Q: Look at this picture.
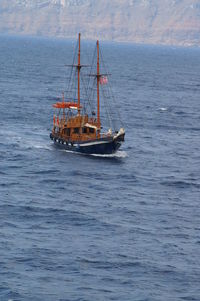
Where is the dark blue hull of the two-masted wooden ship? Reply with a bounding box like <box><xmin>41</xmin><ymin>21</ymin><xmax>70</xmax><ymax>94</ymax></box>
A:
<box><xmin>50</xmin><ymin>133</ymin><xmax>124</xmax><ymax>155</ymax></box>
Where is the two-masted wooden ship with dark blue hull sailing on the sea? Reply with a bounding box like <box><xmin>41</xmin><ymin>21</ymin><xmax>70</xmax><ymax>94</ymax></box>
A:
<box><xmin>50</xmin><ymin>33</ymin><xmax>125</xmax><ymax>155</ymax></box>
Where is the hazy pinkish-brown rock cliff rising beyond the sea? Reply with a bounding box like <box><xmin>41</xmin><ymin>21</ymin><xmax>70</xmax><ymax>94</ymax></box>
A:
<box><xmin>0</xmin><ymin>0</ymin><xmax>200</xmax><ymax>46</ymax></box>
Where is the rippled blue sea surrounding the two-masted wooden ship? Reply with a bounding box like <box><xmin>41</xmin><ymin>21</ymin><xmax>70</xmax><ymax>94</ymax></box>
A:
<box><xmin>0</xmin><ymin>36</ymin><xmax>200</xmax><ymax>301</ymax></box>
